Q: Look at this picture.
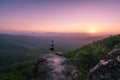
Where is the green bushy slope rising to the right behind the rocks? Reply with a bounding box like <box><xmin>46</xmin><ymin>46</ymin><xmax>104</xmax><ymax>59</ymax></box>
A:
<box><xmin>65</xmin><ymin>35</ymin><xmax>120</xmax><ymax>80</ymax></box>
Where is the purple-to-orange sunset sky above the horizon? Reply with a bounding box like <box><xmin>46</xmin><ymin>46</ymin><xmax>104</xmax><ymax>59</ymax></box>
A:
<box><xmin>0</xmin><ymin>0</ymin><xmax>120</xmax><ymax>34</ymax></box>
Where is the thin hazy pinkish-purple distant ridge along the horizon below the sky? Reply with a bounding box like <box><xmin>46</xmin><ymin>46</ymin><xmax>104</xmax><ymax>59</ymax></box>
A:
<box><xmin>0</xmin><ymin>31</ymin><xmax>90</xmax><ymax>36</ymax></box>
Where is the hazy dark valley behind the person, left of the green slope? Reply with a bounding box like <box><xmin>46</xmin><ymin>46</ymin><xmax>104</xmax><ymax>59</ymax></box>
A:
<box><xmin>0</xmin><ymin>34</ymin><xmax>103</xmax><ymax>80</ymax></box>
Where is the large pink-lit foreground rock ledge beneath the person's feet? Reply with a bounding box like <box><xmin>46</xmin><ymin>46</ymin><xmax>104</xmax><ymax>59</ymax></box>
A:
<box><xmin>32</xmin><ymin>54</ymin><xmax>77</xmax><ymax>80</ymax></box>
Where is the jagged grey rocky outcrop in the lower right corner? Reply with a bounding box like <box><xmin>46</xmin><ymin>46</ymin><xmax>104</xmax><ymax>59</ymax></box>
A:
<box><xmin>89</xmin><ymin>49</ymin><xmax>120</xmax><ymax>80</ymax></box>
